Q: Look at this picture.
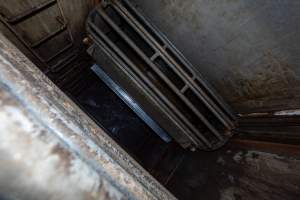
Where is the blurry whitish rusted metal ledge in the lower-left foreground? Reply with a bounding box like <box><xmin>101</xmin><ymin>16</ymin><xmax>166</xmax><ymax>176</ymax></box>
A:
<box><xmin>0</xmin><ymin>34</ymin><xmax>174</xmax><ymax>199</ymax></box>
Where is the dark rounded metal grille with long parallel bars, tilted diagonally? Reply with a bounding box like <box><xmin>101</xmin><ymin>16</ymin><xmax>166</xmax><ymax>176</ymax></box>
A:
<box><xmin>87</xmin><ymin>1</ymin><xmax>234</xmax><ymax>150</ymax></box>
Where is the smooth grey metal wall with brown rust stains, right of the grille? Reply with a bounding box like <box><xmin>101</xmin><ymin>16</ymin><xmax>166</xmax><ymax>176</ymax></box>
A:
<box><xmin>131</xmin><ymin>0</ymin><xmax>300</xmax><ymax>113</ymax></box>
